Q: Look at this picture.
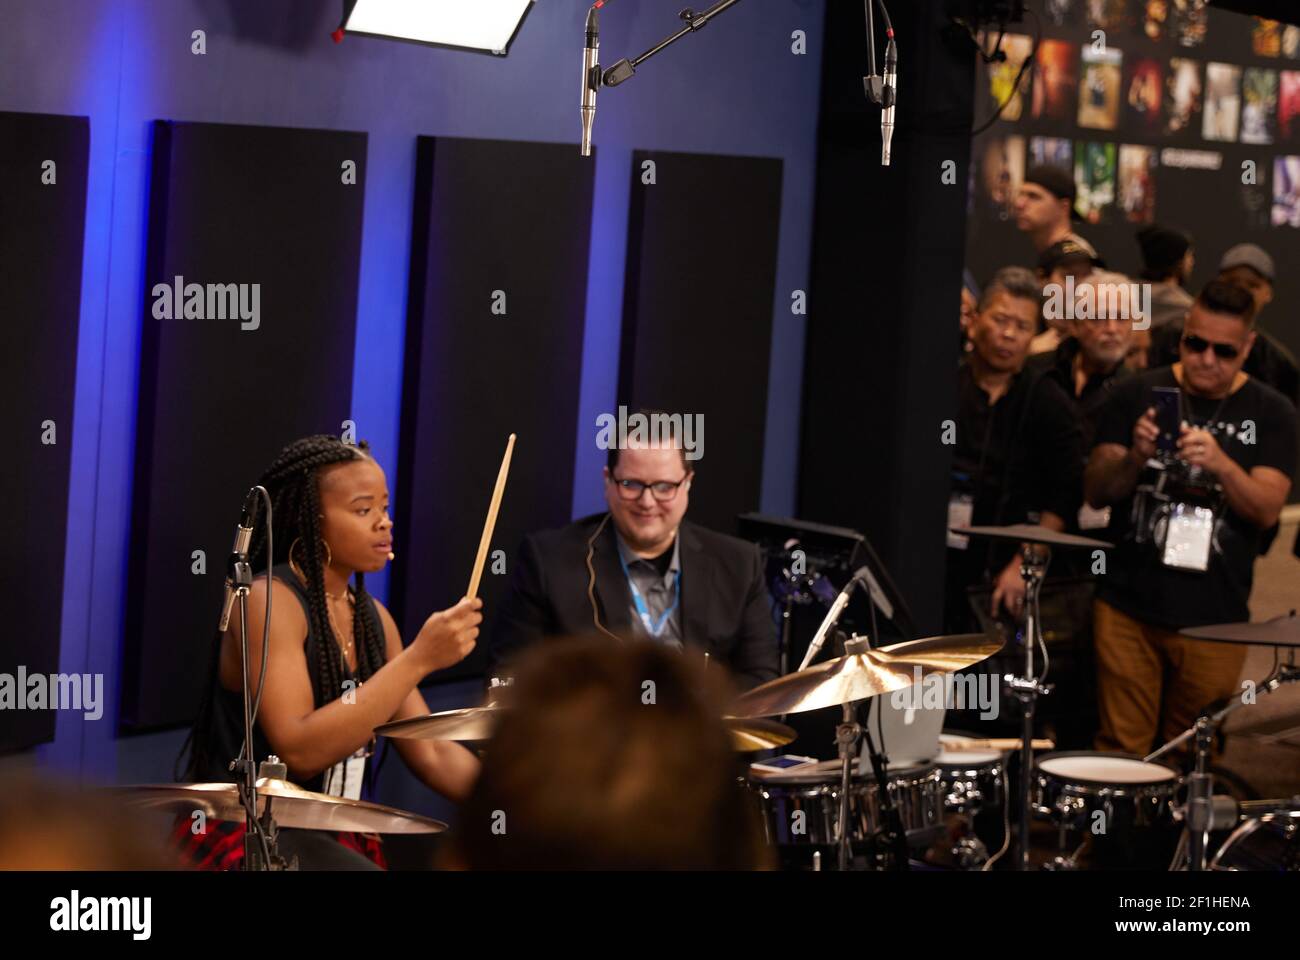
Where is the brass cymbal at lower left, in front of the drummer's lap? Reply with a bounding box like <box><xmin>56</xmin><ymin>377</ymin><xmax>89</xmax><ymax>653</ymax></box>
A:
<box><xmin>109</xmin><ymin>777</ymin><xmax>447</xmax><ymax>834</ymax></box>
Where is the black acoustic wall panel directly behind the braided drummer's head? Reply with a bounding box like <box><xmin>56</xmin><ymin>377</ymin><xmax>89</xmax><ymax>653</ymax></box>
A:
<box><xmin>121</xmin><ymin>121</ymin><xmax>367</xmax><ymax>730</ymax></box>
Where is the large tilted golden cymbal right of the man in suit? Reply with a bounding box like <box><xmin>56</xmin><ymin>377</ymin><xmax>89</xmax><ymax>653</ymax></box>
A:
<box><xmin>731</xmin><ymin>633</ymin><xmax>1002</xmax><ymax>717</ymax></box>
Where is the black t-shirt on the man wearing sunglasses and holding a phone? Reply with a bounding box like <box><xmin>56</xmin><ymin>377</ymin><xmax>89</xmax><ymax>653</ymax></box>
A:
<box><xmin>1097</xmin><ymin>367</ymin><xmax>1296</xmax><ymax>630</ymax></box>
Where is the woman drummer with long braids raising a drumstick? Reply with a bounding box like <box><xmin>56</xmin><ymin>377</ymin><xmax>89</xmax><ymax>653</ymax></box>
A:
<box><xmin>176</xmin><ymin>434</ymin><xmax>482</xmax><ymax>869</ymax></box>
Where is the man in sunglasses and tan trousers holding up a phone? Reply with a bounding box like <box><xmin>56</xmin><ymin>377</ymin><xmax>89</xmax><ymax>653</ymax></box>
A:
<box><xmin>1084</xmin><ymin>280</ymin><xmax>1296</xmax><ymax>756</ymax></box>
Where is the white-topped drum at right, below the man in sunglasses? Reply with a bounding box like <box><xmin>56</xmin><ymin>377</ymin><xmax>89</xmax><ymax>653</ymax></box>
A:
<box><xmin>1034</xmin><ymin>751</ymin><xmax>1180</xmax><ymax>833</ymax></box>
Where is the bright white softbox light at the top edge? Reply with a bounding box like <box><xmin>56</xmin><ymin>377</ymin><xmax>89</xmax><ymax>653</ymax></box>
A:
<box><xmin>343</xmin><ymin>0</ymin><xmax>533</xmax><ymax>56</ymax></box>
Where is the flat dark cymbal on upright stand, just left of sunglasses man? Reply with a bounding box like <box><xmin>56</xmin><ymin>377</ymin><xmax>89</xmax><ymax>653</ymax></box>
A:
<box><xmin>950</xmin><ymin>523</ymin><xmax>1112</xmax><ymax>870</ymax></box>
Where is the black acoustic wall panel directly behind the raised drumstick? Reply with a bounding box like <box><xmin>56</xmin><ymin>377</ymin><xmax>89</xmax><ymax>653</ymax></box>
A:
<box><xmin>393</xmin><ymin>138</ymin><xmax>595</xmax><ymax>680</ymax></box>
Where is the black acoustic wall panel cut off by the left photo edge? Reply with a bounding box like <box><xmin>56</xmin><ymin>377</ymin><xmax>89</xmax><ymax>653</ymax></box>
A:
<box><xmin>0</xmin><ymin>113</ymin><xmax>90</xmax><ymax>753</ymax></box>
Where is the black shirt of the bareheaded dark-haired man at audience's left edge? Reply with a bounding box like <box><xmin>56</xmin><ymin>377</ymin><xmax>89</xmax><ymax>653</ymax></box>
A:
<box><xmin>948</xmin><ymin>363</ymin><xmax>1083</xmax><ymax>591</ymax></box>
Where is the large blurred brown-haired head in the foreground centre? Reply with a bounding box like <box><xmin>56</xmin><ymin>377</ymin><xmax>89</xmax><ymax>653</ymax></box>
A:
<box><xmin>449</xmin><ymin>637</ymin><xmax>770</xmax><ymax>870</ymax></box>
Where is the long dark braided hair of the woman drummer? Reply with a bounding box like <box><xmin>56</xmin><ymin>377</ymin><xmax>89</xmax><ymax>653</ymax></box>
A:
<box><xmin>177</xmin><ymin>433</ymin><xmax>387</xmax><ymax>779</ymax></box>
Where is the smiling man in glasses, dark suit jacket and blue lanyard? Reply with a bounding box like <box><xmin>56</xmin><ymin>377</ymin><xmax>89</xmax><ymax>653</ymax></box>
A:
<box><xmin>489</xmin><ymin>429</ymin><xmax>777</xmax><ymax>689</ymax></box>
